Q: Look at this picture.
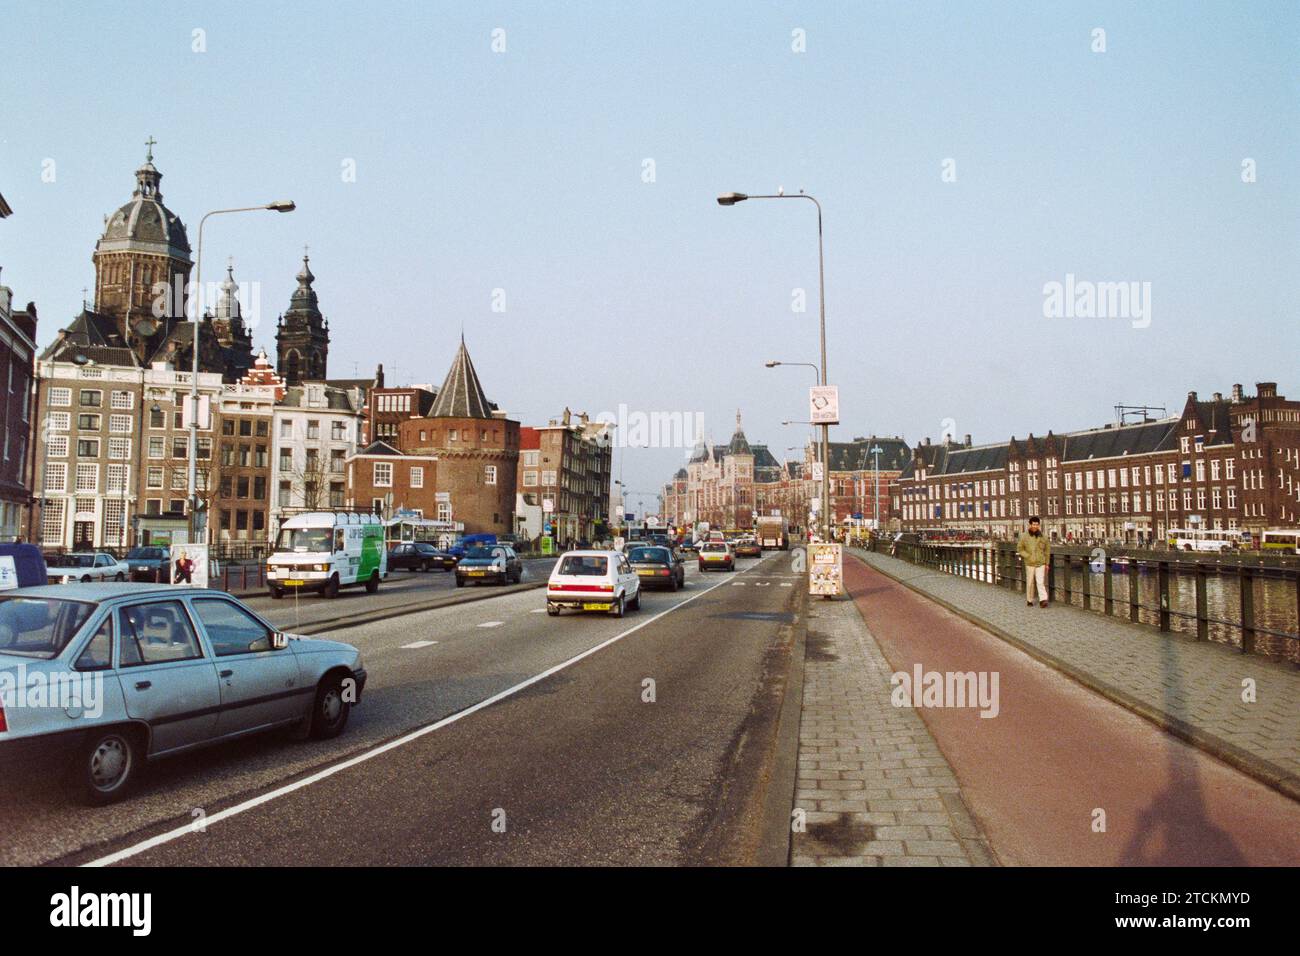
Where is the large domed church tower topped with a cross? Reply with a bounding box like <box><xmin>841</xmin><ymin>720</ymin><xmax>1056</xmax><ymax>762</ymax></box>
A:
<box><xmin>91</xmin><ymin>137</ymin><xmax>192</xmax><ymax>363</ymax></box>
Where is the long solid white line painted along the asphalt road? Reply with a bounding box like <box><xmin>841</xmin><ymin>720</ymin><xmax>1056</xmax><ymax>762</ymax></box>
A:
<box><xmin>82</xmin><ymin>556</ymin><xmax>750</xmax><ymax>868</ymax></box>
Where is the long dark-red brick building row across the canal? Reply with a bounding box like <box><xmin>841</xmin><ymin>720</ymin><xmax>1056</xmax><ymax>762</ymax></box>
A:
<box><xmin>892</xmin><ymin>382</ymin><xmax>1300</xmax><ymax>542</ymax></box>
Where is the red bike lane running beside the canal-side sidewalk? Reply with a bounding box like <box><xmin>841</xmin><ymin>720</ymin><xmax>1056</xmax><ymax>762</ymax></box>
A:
<box><xmin>844</xmin><ymin>558</ymin><xmax>1300</xmax><ymax>866</ymax></box>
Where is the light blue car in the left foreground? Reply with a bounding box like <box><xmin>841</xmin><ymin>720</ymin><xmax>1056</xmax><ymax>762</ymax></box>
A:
<box><xmin>0</xmin><ymin>584</ymin><xmax>365</xmax><ymax>804</ymax></box>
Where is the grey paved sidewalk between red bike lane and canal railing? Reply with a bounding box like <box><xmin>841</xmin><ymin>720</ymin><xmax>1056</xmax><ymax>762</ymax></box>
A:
<box><xmin>852</xmin><ymin>550</ymin><xmax>1300</xmax><ymax>800</ymax></box>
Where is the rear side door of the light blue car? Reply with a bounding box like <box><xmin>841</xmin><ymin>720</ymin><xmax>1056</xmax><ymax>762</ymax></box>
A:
<box><xmin>117</xmin><ymin>600</ymin><xmax>221</xmax><ymax>754</ymax></box>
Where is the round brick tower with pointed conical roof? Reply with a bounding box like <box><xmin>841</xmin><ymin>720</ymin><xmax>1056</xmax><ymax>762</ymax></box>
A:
<box><xmin>398</xmin><ymin>338</ymin><xmax>519</xmax><ymax>535</ymax></box>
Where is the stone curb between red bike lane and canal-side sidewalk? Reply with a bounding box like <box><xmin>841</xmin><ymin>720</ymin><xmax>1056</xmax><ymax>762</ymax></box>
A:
<box><xmin>852</xmin><ymin>554</ymin><xmax>1300</xmax><ymax>803</ymax></box>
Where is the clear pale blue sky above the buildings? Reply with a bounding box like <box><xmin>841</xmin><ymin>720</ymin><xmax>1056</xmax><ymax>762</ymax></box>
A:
<box><xmin>0</xmin><ymin>0</ymin><xmax>1300</xmax><ymax>522</ymax></box>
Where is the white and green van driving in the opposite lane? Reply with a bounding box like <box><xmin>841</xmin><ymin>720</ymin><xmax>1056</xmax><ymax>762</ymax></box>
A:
<box><xmin>267</xmin><ymin>511</ymin><xmax>389</xmax><ymax>600</ymax></box>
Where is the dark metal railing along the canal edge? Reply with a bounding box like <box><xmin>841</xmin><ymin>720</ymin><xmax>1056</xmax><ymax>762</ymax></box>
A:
<box><xmin>870</xmin><ymin>538</ymin><xmax>1300</xmax><ymax>662</ymax></box>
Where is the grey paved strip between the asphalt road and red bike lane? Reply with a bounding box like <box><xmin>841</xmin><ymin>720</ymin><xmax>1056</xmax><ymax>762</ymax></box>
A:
<box><xmin>790</xmin><ymin>590</ymin><xmax>996</xmax><ymax>866</ymax></box>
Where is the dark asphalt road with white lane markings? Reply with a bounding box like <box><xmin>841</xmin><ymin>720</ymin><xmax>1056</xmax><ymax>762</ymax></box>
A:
<box><xmin>0</xmin><ymin>555</ymin><xmax>800</xmax><ymax>865</ymax></box>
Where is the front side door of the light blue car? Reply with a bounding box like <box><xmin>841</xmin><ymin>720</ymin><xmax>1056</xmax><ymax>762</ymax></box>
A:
<box><xmin>190</xmin><ymin>597</ymin><xmax>306</xmax><ymax>737</ymax></box>
